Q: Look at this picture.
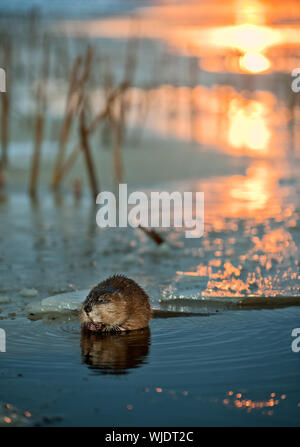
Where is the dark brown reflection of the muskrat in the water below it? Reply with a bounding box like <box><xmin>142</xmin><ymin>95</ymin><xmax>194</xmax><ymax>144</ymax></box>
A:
<box><xmin>81</xmin><ymin>328</ymin><xmax>150</xmax><ymax>374</ymax></box>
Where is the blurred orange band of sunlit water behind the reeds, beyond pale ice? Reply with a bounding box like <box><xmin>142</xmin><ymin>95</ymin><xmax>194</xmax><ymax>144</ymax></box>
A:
<box><xmin>106</xmin><ymin>85</ymin><xmax>289</xmax><ymax>157</ymax></box>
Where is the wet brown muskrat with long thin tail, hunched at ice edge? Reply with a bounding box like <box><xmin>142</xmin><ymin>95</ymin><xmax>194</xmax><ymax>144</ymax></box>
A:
<box><xmin>80</xmin><ymin>275</ymin><xmax>210</xmax><ymax>332</ymax></box>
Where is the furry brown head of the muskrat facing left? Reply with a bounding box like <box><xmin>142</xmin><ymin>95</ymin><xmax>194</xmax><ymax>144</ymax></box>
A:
<box><xmin>80</xmin><ymin>286</ymin><xmax>128</xmax><ymax>332</ymax></box>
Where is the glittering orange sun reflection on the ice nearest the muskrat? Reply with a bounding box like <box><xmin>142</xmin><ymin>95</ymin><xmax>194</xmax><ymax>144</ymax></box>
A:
<box><xmin>165</xmin><ymin>160</ymin><xmax>300</xmax><ymax>299</ymax></box>
